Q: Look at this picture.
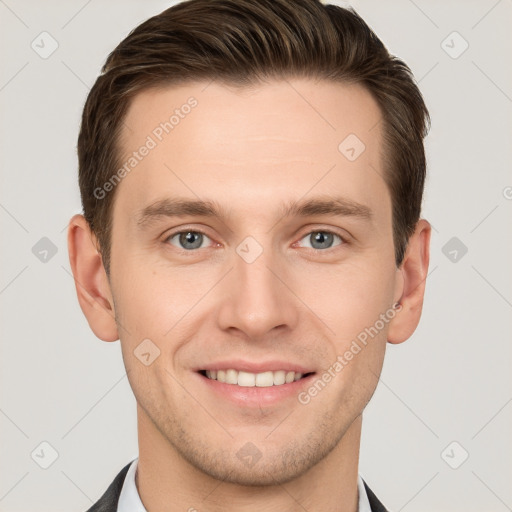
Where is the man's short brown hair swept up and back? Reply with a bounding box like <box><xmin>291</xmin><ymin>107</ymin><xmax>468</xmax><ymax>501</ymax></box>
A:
<box><xmin>78</xmin><ymin>0</ymin><xmax>430</xmax><ymax>274</ymax></box>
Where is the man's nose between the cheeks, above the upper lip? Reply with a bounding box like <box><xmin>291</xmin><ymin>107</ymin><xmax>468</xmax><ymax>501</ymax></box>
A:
<box><xmin>218</xmin><ymin>250</ymin><xmax>299</xmax><ymax>340</ymax></box>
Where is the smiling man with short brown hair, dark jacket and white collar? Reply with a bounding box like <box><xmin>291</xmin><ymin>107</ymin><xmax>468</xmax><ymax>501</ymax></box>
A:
<box><xmin>68</xmin><ymin>0</ymin><xmax>430</xmax><ymax>512</ymax></box>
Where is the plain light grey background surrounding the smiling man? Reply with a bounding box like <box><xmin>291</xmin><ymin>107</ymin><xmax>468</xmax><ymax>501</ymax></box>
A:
<box><xmin>0</xmin><ymin>0</ymin><xmax>512</xmax><ymax>512</ymax></box>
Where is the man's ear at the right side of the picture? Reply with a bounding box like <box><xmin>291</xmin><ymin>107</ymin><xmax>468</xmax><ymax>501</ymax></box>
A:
<box><xmin>388</xmin><ymin>219</ymin><xmax>432</xmax><ymax>343</ymax></box>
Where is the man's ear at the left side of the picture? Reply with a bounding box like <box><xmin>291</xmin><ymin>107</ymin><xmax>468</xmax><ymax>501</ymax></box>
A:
<box><xmin>68</xmin><ymin>215</ymin><xmax>119</xmax><ymax>341</ymax></box>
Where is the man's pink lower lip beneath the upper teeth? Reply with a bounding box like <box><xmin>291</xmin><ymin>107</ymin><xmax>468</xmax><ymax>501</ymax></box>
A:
<box><xmin>197</xmin><ymin>373</ymin><xmax>315</xmax><ymax>407</ymax></box>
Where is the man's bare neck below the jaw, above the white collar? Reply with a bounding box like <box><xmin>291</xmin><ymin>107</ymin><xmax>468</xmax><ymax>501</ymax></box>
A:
<box><xmin>136</xmin><ymin>406</ymin><xmax>362</xmax><ymax>512</ymax></box>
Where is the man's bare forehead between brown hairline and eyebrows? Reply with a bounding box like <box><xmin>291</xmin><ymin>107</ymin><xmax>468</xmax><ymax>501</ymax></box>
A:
<box><xmin>116</xmin><ymin>79</ymin><xmax>386</xmax><ymax>222</ymax></box>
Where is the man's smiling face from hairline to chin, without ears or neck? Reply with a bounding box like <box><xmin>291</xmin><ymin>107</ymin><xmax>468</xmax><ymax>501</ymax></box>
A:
<box><xmin>110</xmin><ymin>79</ymin><xmax>401</xmax><ymax>485</ymax></box>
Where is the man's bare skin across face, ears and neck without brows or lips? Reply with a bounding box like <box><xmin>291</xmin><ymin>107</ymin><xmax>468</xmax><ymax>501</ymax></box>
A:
<box><xmin>68</xmin><ymin>79</ymin><xmax>430</xmax><ymax>512</ymax></box>
